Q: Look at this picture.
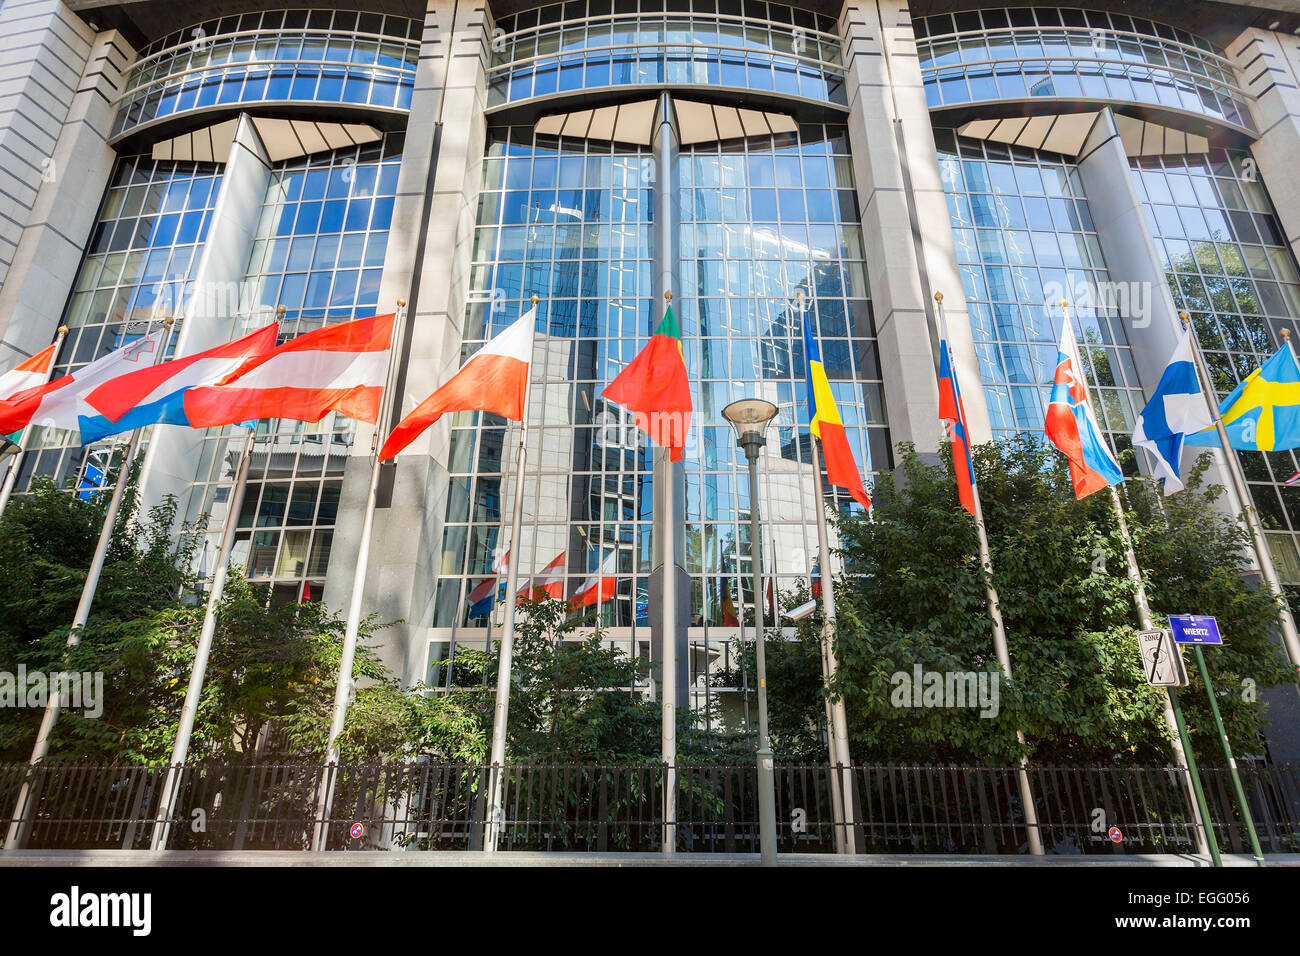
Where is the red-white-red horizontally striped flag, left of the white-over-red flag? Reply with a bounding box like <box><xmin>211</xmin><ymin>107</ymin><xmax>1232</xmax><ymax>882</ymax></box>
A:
<box><xmin>185</xmin><ymin>315</ymin><xmax>394</xmax><ymax>428</ymax></box>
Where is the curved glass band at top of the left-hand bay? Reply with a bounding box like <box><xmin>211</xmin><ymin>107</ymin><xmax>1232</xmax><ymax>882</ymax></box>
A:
<box><xmin>112</xmin><ymin>10</ymin><xmax>423</xmax><ymax>137</ymax></box>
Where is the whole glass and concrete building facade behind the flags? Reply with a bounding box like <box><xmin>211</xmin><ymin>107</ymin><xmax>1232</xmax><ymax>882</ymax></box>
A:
<box><xmin>0</xmin><ymin>0</ymin><xmax>1300</xmax><ymax>749</ymax></box>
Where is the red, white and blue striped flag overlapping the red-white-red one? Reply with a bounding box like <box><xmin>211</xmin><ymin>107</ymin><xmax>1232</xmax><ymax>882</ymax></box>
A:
<box><xmin>79</xmin><ymin>323</ymin><xmax>280</xmax><ymax>445</ymax></box>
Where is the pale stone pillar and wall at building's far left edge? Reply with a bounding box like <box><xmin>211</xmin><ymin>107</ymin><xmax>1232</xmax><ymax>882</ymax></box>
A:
<box><xmin>0</xmin><ymin>18</ymin><xmax>135</xmax><ymax>368</ymax></box>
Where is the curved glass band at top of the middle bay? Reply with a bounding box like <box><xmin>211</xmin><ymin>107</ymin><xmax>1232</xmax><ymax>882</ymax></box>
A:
<box><xmin>488</xmin><ymin>0</ymin><xmax>846</xmax><ymax>107</ymax></box>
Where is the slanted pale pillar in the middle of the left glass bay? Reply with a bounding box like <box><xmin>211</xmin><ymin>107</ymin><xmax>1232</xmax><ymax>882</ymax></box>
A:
<box><xmin>140</xmin><ymin>113</ymin><xmax>274</xmax><ymax>527</ymax></box>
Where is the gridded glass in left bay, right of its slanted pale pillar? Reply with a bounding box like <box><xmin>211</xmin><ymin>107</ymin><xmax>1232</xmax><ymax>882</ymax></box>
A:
<box><xmin>187</xmin><ymin>134</ymin><xmax>403</xmax><ymax>600</ymax></box>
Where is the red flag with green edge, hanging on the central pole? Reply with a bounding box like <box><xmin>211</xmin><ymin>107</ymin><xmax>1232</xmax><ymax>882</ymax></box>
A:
<box><xmin>601</xmin><ymin>306</ymin><xmax>692</xmax><ymax>462</ymax></box>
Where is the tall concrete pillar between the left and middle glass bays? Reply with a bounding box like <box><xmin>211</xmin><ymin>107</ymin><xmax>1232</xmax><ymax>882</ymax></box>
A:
<box><xmin>322</xmin><ymin>0</ymin><xmax>488</xmax><ymax>683</ymax></box>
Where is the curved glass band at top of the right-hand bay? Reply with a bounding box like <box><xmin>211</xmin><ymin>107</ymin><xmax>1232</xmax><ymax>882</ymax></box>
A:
<box><xmin>913</xmin><ymin>7</ymin><xmax>1255</xmax><ymax>130</ymax></box>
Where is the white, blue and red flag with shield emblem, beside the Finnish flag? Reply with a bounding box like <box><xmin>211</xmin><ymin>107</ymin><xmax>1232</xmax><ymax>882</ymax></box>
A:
<box><xmin>1044</xmin><ymin>320</ymin><xmax>1125</xmax><ymax>498</ymax></box>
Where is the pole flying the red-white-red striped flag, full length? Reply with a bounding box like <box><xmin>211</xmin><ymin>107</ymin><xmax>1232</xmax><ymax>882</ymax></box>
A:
<box><xmin>312</xmin><ymin>299</ymin><xmax>406</xmax><ymax>851</ymax></box>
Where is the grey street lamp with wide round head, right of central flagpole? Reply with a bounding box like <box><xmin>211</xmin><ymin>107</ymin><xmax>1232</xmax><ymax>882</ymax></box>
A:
<box><xmin>723</xmin><ymin>398</ymin><xmax>776</xmax><ymax>866</ymax></box>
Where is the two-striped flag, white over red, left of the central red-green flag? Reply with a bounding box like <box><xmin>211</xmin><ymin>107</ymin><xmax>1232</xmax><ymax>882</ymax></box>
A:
<box><xmin>380</xmin><ymin>308</ymin><xmax>537</xmax><ymax>462</ymax></box>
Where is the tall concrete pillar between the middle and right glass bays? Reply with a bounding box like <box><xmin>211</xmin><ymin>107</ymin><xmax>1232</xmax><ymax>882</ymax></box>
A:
<box><xmin>840</xmin><ymin>0</ymin><xmax>992</xmax><ymax>453</ymax></box>
